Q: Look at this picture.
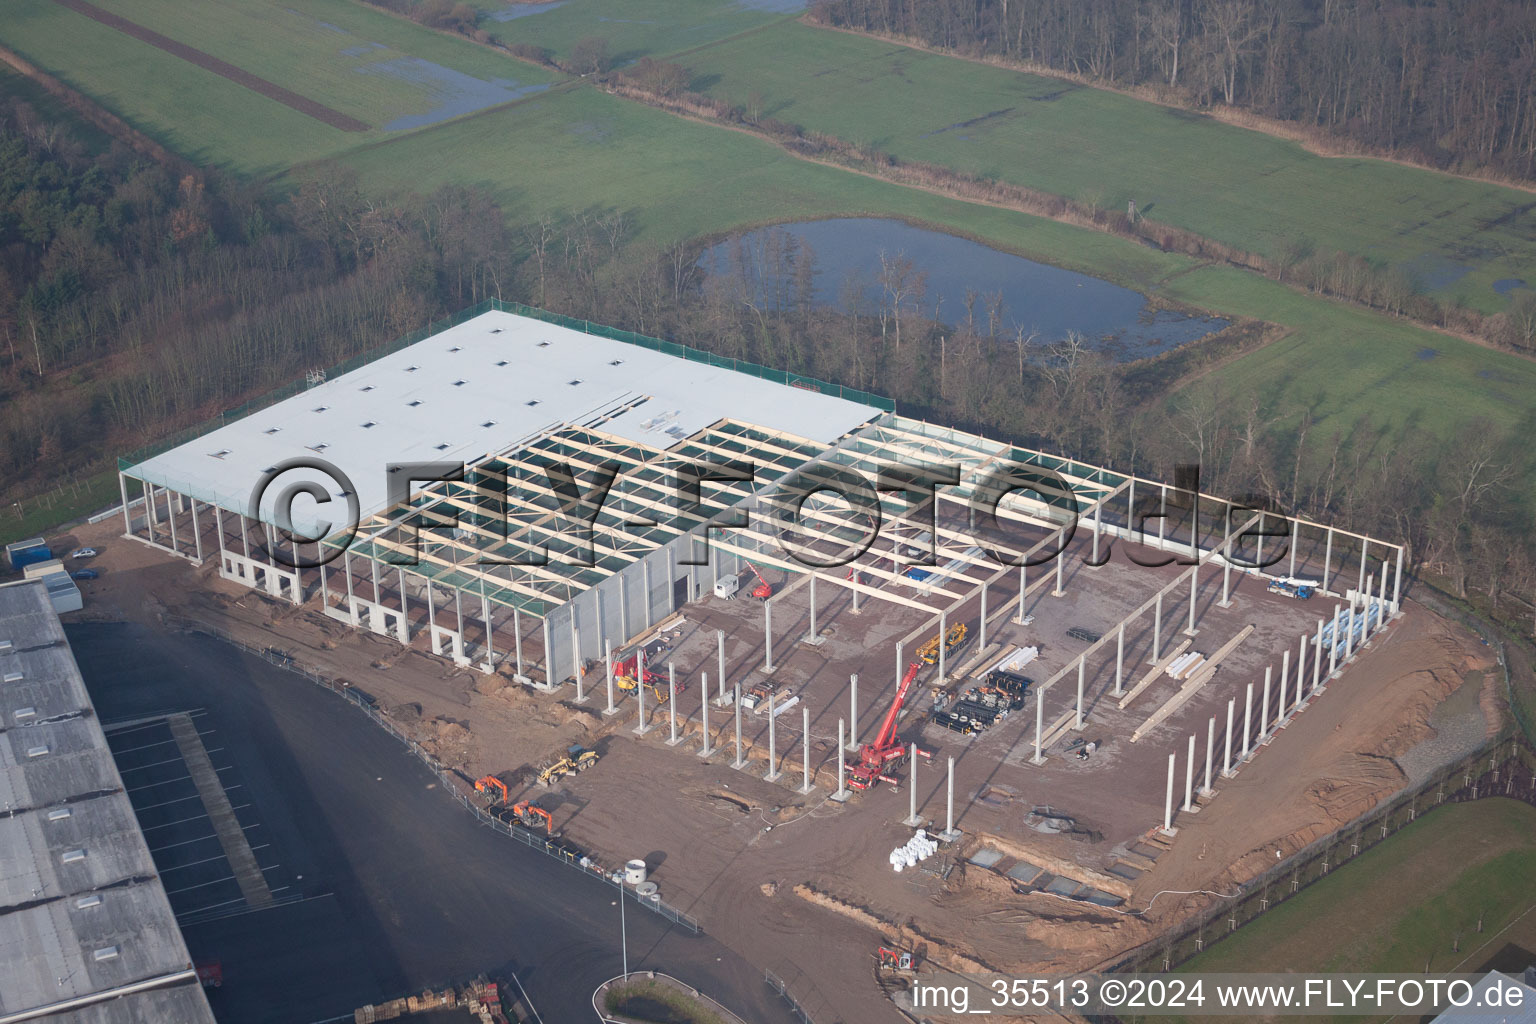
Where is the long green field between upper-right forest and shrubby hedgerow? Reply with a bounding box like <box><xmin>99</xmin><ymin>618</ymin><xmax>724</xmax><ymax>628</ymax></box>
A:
<box><xmin>684</xmin><ymin>21</ymin><xmax>1536</xmax><ymax>310</ymax></box>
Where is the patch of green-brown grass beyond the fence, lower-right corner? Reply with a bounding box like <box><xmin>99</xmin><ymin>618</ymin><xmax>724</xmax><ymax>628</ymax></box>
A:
<box><xmin>1180</xmin><ymin>798</ymin><xmax>1536</xmax><ymax>973</ymax></box>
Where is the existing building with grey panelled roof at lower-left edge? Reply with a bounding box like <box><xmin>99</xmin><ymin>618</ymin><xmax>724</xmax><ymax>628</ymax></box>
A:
<box><xmin>0</xmin><ymin>580</ymin><xmax>214</xmax><ymax>1024</ymax></box>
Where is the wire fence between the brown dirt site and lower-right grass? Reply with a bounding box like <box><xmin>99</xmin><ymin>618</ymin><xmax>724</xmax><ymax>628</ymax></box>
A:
<box><xmin>1106</xmin><ymin>731</ymin><xmax>1536</xmax><ymax>973</ymax></box>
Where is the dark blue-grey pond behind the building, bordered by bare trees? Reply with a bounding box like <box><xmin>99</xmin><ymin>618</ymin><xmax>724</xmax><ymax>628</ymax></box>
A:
<box><xmin>699</xmin><ymin>216</ymin><xmax>1227</xmax><ymax>362</ymax></box>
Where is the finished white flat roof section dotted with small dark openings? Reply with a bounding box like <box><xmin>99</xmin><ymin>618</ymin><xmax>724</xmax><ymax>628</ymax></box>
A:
<box><xmin>127</xmin><ymin>312</ymin><xmax>883</xmax><ymax>536</ymax></box>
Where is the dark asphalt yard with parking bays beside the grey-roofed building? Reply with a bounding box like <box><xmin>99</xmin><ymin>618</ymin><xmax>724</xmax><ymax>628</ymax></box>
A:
<box><xmin>69</xmin><ymin>623</ymin><xmax>794</xmax><ymax>1024</ymax></box>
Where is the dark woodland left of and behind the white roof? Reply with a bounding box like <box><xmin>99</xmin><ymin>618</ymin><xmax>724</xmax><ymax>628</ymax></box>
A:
<box><xmin>0</xmin><ymin>98</ymin><xmax>510</xmax><ymax>499</ymax></box>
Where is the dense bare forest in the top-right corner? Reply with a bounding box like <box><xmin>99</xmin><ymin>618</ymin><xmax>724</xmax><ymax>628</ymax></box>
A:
<box><xmin>811</xmin><ymin>0</ymin><xmax>1536</xmax><ymax>178</ymax></box>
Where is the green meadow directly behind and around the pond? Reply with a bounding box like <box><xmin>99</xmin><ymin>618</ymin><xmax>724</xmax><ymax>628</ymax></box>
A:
<box><xmin>344</xmin><ymin>88</ymin><xmax>1536</xmax><ymax>466</ymax></box>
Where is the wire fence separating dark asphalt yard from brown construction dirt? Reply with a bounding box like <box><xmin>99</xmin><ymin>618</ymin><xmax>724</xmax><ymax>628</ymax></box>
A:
<box><xmin>186</xmin><ymin>623</ymin><xmax>703</xmax><ymax>935</ymax></box>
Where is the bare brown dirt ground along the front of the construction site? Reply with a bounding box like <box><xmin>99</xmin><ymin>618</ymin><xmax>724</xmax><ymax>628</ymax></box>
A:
<box><xmin>54</xmin><ymin>520</ymin><xmax>1498</xmax><ymax>1024</ymax></box>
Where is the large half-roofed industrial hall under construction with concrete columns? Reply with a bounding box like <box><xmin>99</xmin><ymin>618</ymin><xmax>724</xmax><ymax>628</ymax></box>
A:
<box><xmin>120</xmin><ymin>304</ymin><xmax>1402</xmax><ymax>827</ymax></box>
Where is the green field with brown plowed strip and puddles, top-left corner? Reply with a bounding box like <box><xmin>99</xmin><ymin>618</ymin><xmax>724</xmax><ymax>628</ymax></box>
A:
<box><xmin>0</xmin><ymin>0</ymin><xmax>554</xmax><ymax>173</ymax></box>
